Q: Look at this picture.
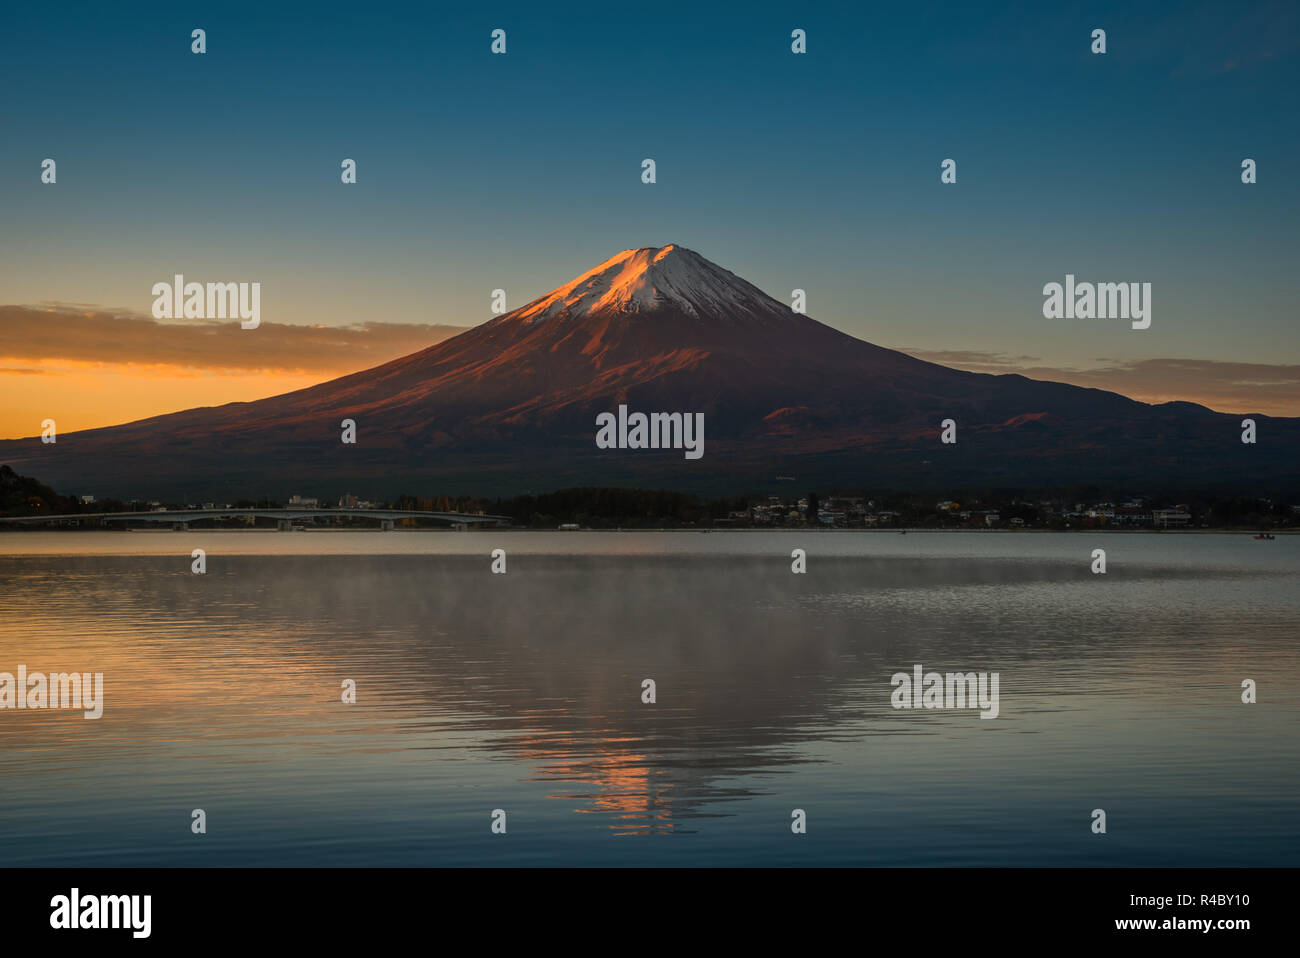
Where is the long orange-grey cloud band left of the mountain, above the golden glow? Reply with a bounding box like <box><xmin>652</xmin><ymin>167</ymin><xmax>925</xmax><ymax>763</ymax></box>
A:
<box><xmin>0</xmin><ymin>303</ymin><xmax>464</xmax><ymax>374</ymax></box>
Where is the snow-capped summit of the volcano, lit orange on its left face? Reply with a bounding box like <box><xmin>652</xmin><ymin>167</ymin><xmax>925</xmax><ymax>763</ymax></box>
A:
<box><xmin>515</xmin><ymin>243</ymin><xmax>788</xmax><ymax>322</ymax></box>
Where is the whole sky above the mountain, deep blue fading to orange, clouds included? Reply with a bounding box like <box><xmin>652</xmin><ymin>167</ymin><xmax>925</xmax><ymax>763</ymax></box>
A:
<box><xmin>0</xmin><ymin>3</ymin><xmax>1300</xmax><ymax>438</ymax></box>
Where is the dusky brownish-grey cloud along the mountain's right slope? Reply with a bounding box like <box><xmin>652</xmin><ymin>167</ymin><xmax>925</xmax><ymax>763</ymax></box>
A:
<box><xmin>902</xmin><ymin>347</ymin><xmax>1300</xmax><ymax>416</ymax></box>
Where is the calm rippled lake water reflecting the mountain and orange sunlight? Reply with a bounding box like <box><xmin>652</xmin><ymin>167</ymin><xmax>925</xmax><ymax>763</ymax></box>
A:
<box><xmin>0</xmin><ymin>530</ymin><xmax>1300</xmax><ymax>866</ymax></box>
